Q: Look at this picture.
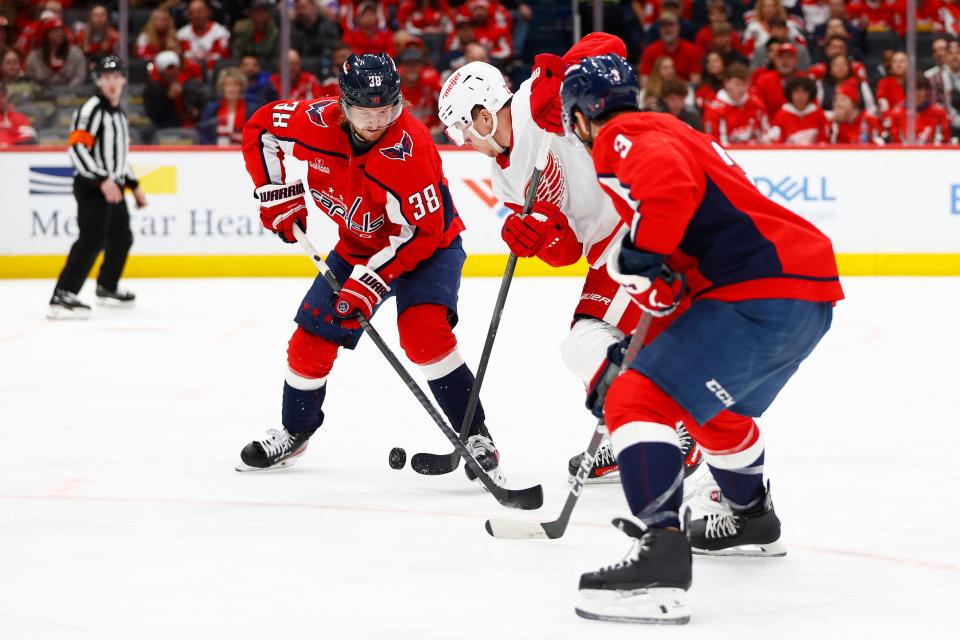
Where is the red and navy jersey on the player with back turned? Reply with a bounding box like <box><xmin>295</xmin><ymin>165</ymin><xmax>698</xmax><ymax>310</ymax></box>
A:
<box><xmin>593</xmin><ymin>113</ymin><xmax>843</xmax><ymax>302</ymax></box>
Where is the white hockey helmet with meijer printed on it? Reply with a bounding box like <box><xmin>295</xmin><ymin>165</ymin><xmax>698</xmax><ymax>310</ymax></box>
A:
<box><xmin>437</xmin><ymin>61</ymin><xmax>513</xmax><ymax>153</ymax></box>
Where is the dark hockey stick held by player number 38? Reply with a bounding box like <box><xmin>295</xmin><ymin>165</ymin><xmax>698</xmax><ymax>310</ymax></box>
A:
<box><xmin>293</xmin><ymin>224</ymin><xmax>543</xmax><ymax>509</ymax></box>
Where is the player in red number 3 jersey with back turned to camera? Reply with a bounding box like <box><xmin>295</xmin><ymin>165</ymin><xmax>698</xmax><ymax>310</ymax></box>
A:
<box><xmin>561</xmin><ymin>55</ymin><xmax>843</xmax><ymax>624</ymax></box>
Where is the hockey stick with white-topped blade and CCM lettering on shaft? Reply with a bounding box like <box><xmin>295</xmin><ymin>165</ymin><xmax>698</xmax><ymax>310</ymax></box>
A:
<box><xmin>485</xmin><ymin>312</ymin><xmax>653</xmax><ymax>540</ymax></box>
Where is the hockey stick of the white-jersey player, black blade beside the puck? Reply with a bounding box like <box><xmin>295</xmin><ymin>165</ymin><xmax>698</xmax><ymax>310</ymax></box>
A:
<box><xmin>410</xmin><ymin>133</ymin><xmax>553</xmax><ymax>476</ymax></box>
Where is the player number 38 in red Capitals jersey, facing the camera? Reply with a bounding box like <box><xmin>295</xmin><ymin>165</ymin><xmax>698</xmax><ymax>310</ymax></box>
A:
<box><xmin>238</xmin><ymin>54</ymin><xmax>503</xmax><ymax>483</ymax></box>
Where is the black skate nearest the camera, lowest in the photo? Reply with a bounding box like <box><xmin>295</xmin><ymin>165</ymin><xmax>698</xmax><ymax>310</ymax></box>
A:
<box><xmin>576</xmin><ymin>518</ymin><xmax>693</xmax><ymax>624</ymax></box>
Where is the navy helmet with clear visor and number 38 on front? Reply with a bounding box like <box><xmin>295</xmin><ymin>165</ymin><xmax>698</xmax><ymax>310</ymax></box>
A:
<box><xmin>339</xmin><ymin>53</ymin><xmax>403</xmax><ymax>129</ymax></box>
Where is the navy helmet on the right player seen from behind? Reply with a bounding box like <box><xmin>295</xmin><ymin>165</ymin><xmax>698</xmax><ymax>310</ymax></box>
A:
<box><xmin>560</xmin><ymin>53</ymin><xmax>640</xmax><ymax>139</ymax></box>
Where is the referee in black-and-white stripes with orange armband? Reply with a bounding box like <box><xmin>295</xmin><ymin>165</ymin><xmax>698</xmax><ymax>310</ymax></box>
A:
<box><xmin>47</xmin><ymin>56</ymin><xmax>147</xmax><ymax>320</ymax></box>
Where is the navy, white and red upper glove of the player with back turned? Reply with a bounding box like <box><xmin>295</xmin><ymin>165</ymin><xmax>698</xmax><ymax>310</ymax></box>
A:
<box><xmin>607</xmin><ymin>236</ymin><xmax>687</xmax><ymax>318</ymax></box>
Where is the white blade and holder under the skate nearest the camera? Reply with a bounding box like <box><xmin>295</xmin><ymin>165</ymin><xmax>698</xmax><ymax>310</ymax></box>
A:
<box><xmin>575</xmin><ymin>587</ymin><xmax>690</xmax><ymax>624</ymax></box>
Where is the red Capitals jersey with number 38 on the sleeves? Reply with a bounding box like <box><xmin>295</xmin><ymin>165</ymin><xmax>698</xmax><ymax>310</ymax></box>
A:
<box><xmin>243</xmin><ymin>99</ymin><xmax>464</xmax><ymax>283</ymax></box>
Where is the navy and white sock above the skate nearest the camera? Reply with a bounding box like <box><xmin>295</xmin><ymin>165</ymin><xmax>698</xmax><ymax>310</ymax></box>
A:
<box><xmin>610</xmin><ymin>422</ymin><xmax>683</xmax><ymax>528</ymax></box>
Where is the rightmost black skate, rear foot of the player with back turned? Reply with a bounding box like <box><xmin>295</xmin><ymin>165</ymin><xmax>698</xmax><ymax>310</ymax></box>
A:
<box><xmin>689</xmin><ymin>487</ymin><xmax>787</xmax><ymax>557</ymax></box>
